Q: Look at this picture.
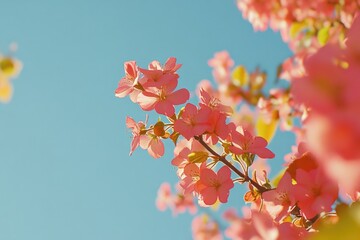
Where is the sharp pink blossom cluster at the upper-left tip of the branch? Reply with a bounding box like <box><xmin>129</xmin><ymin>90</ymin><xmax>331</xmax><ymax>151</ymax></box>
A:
<box><xmin>115</xmin><ymin>58</ymin><xmax>190</xmax><ymax>117</ymax></box>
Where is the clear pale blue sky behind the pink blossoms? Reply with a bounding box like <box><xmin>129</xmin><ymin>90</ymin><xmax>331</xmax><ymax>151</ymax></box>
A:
<box><xmin>0</xmin><ymin>0</ymin><xmax>290</xmax><ymax>240</ymax></box>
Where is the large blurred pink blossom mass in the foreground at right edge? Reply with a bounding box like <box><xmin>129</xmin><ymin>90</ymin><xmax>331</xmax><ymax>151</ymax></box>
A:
<box><xmin>292</xmin><ymin>13</ymin><xmax>360</xmax><ymax>199</ymax></box>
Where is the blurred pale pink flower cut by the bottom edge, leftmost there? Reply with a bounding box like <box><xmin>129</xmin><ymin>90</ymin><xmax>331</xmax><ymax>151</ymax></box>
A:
<box><xmin>191</xmin><ymin>215</ymin><xmax>223</xmax><ymax>240</ymax></box>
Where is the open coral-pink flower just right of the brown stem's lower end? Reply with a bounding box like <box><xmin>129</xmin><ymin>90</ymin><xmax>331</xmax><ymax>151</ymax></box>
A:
<box><xmin>291</xmin><ymin>169</ymin><xmax>338</xmax><ymax>219</ymax></box>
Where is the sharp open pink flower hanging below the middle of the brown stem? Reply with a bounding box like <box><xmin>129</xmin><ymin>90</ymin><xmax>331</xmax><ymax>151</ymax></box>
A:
<box><xmin>200</xmin><ymin>166</ymin><xmax>234</xmax><ymax>205</ymax></box>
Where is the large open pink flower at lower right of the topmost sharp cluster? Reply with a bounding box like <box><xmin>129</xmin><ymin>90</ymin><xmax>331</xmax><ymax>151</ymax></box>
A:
<box><xmin>137</xmin><ymin>75</ymin><xmax>190</xmax><ymax>117</ymax></box>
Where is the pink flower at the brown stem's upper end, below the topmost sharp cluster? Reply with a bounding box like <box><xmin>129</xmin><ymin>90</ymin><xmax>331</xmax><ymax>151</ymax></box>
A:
<box><xmin>174</xmin><ymin>103</ymin><xmax>211</xmax><ymax>140</ymax></box>
